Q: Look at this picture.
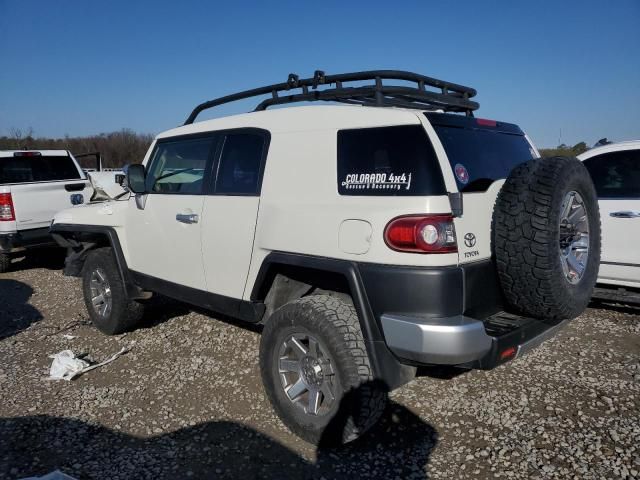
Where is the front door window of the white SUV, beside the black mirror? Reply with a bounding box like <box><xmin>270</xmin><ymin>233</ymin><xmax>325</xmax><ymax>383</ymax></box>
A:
<box><xmin>147</xmin><ymin>137</ymin><xmax>214</xmax><ymax>195</ymax></box>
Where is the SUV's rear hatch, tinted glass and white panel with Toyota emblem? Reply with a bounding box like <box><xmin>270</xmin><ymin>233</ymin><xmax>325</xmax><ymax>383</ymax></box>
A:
<box><xmin>425</xmin><ymin>113</ymin><xmax>539</xmax><ymax>263</ymax></box>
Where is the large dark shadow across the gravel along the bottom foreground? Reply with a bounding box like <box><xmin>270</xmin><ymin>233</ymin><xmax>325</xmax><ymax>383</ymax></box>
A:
<box><xmin>0</xmin><ymin>402</ymin><xmax>437</xmax><ymax>480</ymax></box>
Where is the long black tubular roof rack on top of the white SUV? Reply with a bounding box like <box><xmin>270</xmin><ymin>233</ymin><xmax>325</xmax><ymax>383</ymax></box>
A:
<box><xmin>184</xmin><ymin>70</ymin><xmax>480</xmax><ymax>125</ymax></box>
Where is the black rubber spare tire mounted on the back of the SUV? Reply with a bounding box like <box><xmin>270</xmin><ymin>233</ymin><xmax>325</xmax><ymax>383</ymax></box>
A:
<box><xmin>492</xmin><ymin>157</ymin><xmax>600</xmax><ymax>320</ymax></box>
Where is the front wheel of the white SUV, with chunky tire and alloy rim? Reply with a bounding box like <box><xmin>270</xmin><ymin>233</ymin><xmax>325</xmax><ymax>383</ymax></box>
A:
<box><xmin>82</xmin><ymin>248</ymin><xmax>144</xmax><ymax>335</ymax></box>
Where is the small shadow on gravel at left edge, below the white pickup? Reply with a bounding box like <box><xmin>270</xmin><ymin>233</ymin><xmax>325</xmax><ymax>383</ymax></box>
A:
<box><xmin>0</xmin><ymin>279</ymin><xmax>42</xmax><ymax>340</ymax></box>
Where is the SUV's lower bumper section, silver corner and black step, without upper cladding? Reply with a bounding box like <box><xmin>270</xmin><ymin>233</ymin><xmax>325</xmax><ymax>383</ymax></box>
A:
<box><xmin>382</xmin><ymin>312</ymin><xmax>568</xmax><ymax>370</ymax></box>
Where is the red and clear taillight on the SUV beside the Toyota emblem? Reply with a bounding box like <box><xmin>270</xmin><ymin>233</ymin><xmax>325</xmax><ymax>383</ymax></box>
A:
<box><xmin>384</xmin><ymin>214</ymin><xmax>458</xmax><ymax>253</ymax></box>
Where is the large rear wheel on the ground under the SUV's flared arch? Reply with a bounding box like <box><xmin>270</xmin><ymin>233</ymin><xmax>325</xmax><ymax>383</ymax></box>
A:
<box><xmin>260</xmin><ymin>295</ymin><xmax>387</xmax><ymax>446</ymax></box>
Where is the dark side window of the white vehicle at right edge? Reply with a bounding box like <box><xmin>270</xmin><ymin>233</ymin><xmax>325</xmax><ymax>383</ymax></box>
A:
<box><xmin>584</xmin><ymin>150</ymin><xmax>640</xmax><ymax>198</ymax></box>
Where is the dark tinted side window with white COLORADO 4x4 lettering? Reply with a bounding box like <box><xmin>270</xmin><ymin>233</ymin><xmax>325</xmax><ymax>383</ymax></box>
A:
<box><xmin>338</xmin><ymin>125</ymin><xmax>446</xmax><ymax>196</ymax></box>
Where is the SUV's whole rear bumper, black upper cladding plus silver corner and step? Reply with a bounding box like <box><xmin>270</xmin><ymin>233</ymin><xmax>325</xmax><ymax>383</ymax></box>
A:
<box><xmin>359</xmin><ymin>260</ymin><xmax>563</xmax><ymax>369</ymax></box>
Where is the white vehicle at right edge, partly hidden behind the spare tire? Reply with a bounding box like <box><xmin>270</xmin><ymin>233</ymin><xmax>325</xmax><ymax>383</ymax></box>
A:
<box><xmin>578</xmin><ymin>140</ymin><xmax>640</xmax><ymax>304</ymax></box>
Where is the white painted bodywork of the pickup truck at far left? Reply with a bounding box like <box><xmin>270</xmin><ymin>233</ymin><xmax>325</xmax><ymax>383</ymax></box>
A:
<box><xmin>0</xmin><ymin>150</ymin><xmax>93</xmax><ymax>232</ymax></box>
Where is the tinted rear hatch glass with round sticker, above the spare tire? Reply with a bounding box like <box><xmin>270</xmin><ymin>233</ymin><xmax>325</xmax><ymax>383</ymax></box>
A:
<box><xmin>426</xmin><ymin>113</ymin><xmax>535</xmax><ymax>192</ymax></box>
